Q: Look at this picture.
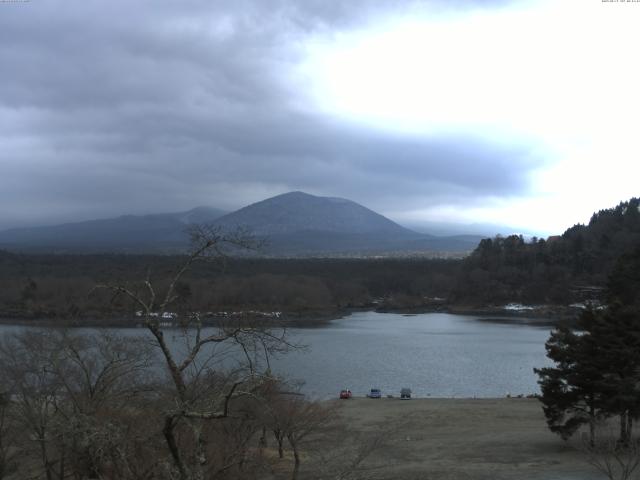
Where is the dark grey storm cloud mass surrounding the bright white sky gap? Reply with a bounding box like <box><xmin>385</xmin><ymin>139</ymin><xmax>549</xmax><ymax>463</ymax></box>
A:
<box><xmin>0</xmin><ymin>0</ymin><xmax>534</xmax><ymax>227</ymax></box>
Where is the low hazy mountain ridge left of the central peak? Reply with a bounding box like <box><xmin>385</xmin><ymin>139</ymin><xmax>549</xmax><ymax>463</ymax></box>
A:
<box><xmin>0</xmin><ymin>207</ymin><xmax>226</xmax><ymax>252</ymax></box>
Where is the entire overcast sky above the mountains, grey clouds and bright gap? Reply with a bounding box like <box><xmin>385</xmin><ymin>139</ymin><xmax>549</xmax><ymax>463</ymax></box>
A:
<box><xmin>0</xmin><ymin>0</ymin><xmax>640</xmax><ymax>234</ymax></box>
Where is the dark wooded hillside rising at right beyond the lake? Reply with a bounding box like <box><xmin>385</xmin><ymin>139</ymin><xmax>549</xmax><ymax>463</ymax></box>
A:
<box><xmin>453</xmin><ymin>198</ymin><xmax>640</xmax><ymax>304</ymax></box>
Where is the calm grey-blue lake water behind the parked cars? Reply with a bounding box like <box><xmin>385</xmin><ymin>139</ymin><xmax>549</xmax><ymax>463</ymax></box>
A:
<box><xmin>0</xmin><ymin>312</ymin><xmax>550</xmax><ymax>398</ymax></box>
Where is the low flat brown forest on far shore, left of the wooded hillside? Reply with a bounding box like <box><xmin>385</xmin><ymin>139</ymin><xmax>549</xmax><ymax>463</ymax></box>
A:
<box><xmin>0</xmin><ymin>253</ymin><xmax>460</xmax><ymax>319</ymax></box>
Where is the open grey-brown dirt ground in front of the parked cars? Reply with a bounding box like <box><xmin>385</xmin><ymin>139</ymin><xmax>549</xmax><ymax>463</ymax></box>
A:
<box><xmin>301</xmin><ymin>398</ymin><xmax>604</xmax><ymax>480</ymax></box>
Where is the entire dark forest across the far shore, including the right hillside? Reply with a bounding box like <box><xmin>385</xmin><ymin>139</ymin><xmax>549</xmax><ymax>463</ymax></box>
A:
<box><xmin>0</xmin><ymin>198</ymin><xmax>640</xmax><ymax>321</ymax></box>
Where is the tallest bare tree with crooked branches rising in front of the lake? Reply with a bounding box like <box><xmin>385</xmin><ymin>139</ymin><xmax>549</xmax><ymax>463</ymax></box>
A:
<box><xmin>96</xmin><ymin>226</ymin><xmax>291</xmax><ymax>480</ymax></box>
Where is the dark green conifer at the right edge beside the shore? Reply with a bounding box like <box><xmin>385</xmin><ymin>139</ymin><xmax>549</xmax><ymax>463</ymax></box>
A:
<box><xmin>536</xmin><ymin>249</ymin><xmax>640</xmax><ymax>444</ymax></box>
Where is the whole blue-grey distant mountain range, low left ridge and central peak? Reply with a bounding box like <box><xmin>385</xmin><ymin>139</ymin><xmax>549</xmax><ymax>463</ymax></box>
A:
<box><xmin>0</xmin><ymin>192</ymin><xmax>483</xmax><ymax>256</ymax></box>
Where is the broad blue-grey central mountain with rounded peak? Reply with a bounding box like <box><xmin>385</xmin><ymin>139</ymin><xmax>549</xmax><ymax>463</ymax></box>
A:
<box><xmin>215</xmin><ymin>192</ymin><xmax>482</xmax><ymax>256</ymax></box>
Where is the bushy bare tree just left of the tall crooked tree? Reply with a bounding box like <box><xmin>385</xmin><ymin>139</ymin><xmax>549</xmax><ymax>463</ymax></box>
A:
<box><xmin>48</xmin><ymin>331</ymin><xmax>152</xmax><ymax>478</ymax></box>
